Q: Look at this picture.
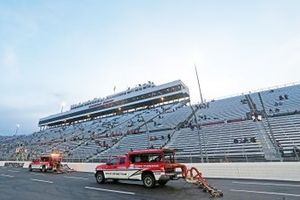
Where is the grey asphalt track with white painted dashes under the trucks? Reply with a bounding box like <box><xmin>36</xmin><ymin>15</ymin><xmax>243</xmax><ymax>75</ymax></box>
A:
<box><xmin>0</xmin><ymin>167</ymin><xmax>300</xmax><ymax>200</ymax></box>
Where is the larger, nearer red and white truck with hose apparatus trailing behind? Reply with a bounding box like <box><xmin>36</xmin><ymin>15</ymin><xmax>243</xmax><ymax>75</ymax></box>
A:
<box><xmin>95</xmin><ymin>149</ymin><xmax>223</xmax><ymax>197</ymax></box>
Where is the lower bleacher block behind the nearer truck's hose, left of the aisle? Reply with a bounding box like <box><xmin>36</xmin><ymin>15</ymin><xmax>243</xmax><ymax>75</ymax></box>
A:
<box><xmin>167</xmin><ymin>120</ymin><xmax>264</xmax><ymax>161</ymax></box>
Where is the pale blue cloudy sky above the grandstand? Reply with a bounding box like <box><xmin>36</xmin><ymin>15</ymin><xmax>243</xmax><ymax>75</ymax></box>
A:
<box><xmin>0</xmin><ymin>0</ymin><xmax>300</xmax><ymax>135</ymax></box>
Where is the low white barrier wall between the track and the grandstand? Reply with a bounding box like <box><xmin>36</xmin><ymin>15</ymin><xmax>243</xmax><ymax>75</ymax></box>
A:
<box><xmin>0</xmin><ymin>161</ymin><xmax>300</xmax><ymax>181</ymax></box>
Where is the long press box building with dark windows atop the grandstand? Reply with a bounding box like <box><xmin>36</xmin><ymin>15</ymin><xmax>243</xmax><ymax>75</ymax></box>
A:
<box><xmin>39</xmin><ymin>80</ymin><xmax>189</xmax><ymax>127</ymax></box>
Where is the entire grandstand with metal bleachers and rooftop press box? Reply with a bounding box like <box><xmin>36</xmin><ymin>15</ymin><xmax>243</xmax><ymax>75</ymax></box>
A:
<box><xmin>0</xmin><ymin>81</ymin><xmax>300</xmax><ymax>162</ymax></box>
